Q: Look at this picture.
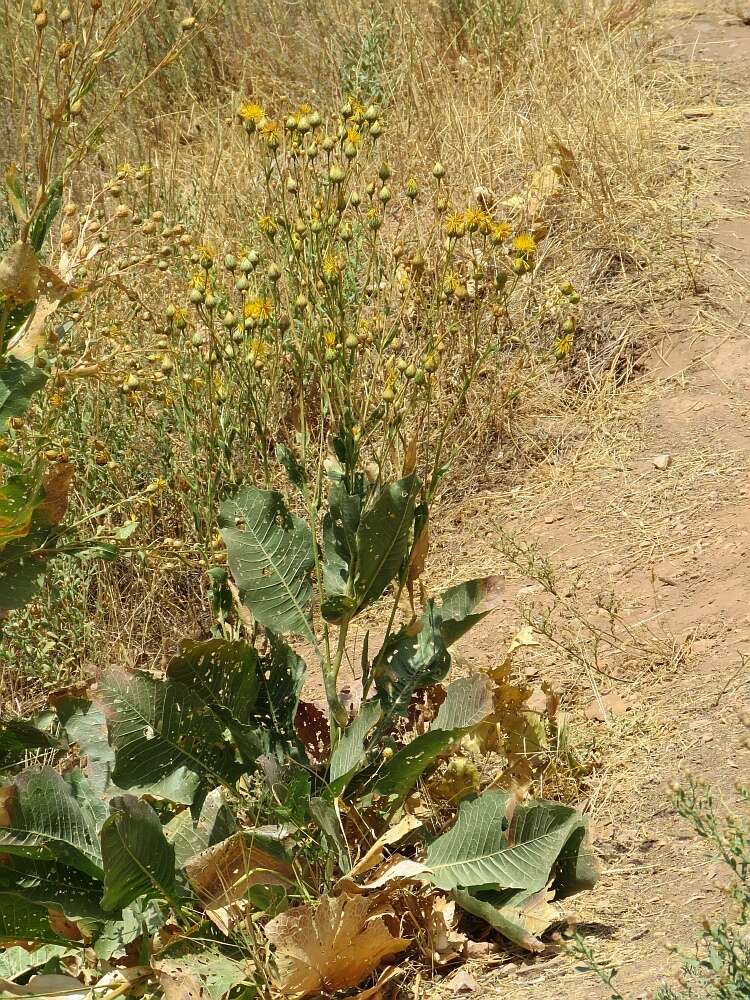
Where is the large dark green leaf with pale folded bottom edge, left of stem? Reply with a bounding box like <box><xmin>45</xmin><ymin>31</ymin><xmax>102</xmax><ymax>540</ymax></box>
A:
<box><xmin>101</xmin><ymin>673</ymin><xmax>242</xmax><ymax>805</ymax></box>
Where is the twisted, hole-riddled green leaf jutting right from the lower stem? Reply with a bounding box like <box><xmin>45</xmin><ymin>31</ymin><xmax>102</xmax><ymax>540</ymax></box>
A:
<box><xmin>373</xmin><ymin>577</ymin><xmax>496</xmax><ymax>727</ymax></box>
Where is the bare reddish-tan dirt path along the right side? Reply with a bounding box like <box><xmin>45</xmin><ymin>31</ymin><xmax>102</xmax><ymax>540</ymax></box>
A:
<box><xmin>424</xmin><ymin>2</ymin><xmax>750</xmax><ymax>1000</ymax></box>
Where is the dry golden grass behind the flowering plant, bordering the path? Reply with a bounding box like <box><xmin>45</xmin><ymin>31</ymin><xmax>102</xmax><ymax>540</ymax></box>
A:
<box><xmin>0</xmin><ymin>0</ymin><xmax>728</xmax><ymax>697</ymax></box>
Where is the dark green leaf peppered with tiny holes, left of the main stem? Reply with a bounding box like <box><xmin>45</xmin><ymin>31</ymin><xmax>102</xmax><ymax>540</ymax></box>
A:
<box><xmin>167</xmin><ymin>639</ymin><xmax>259</xmax><ymax>722</ymax></box>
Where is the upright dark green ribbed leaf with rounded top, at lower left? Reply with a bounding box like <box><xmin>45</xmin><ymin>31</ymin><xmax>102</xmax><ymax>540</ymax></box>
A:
<box><xmin>102</xmin><ymin>795</ymin><xmax>175</xmax><ymax>910</ymax></box>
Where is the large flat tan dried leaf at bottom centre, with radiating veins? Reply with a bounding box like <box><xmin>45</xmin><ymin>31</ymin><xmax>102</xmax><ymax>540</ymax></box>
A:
<box><xmin>265</xmin><ymin>894</ymin><xmax>411</xmax><ymax>997</ymax></box>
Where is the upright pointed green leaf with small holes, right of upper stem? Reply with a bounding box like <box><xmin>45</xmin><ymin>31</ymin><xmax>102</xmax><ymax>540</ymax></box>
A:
<box><xmin>352</xmin><ymin>475</ymin><xmax>419</xmax><ymax>617</ymax></box>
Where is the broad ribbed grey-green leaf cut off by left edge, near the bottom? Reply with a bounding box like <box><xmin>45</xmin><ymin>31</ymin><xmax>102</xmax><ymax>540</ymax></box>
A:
<box><xmin>0</xmin><ymin>767</ymin><xmax>102</xmax><ymax>878</ymax></box>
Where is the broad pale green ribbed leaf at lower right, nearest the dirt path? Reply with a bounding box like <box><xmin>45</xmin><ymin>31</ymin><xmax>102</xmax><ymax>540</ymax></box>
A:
<box><xmin>427</xmin><ymin>791</ymin><xmax>585</xmax><ymax>891</ymax></box>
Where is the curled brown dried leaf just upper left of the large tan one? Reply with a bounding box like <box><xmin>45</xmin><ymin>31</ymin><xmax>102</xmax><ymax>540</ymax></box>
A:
<box><xmin>185</xmin><ymin>831</ymin><xmax>294</xmax><ymax>929</ymax></box>
